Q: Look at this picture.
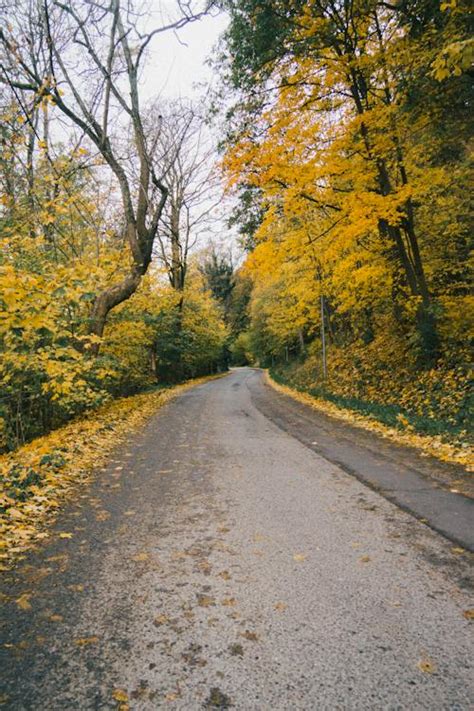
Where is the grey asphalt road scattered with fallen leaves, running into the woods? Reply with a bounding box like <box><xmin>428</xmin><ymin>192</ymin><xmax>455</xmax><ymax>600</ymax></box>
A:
<box><xmin>0</xmin><ymin>369</ymin><xmax>474</xmax><ymax>711</ymax></box>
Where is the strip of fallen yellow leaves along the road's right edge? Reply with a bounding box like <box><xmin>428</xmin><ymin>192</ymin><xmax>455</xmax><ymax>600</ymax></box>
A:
<box><xmin>267</xmin><ymin>369</ymin><xmax>474</xmax><ymax>472</ymax></box>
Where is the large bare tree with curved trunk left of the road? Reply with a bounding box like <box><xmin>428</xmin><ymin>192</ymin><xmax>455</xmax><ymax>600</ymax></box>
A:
<box><xmin>0</xmin><ymin>0</ymin><xmax>213</xmax><ymax>352</ymax></box>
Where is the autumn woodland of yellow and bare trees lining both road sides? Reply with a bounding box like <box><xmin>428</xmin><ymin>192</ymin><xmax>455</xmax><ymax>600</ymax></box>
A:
<box><xmin>0</xmin><ymin>0</ymin><xmax>473</xmax><ymax>456</ymax></box>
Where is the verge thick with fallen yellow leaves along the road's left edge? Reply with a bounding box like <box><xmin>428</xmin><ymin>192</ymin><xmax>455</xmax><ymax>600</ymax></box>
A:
<box><xmin>0</xmin><ymin>374</ymin><xmax>226</xmax><ymax>570</ymax></box>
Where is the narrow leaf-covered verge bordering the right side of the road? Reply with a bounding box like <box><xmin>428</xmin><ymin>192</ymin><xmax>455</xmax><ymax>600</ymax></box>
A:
<box><xmin>266</xmin><ymin>371</ymin><xmax>474</xmax><ymax>472</ymax></box>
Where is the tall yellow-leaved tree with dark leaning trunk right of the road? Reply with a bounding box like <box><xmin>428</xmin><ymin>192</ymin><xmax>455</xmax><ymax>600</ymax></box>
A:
<box><xmin>221</xmin><ymin>0</ymin><xmax>470</xmax><ymax>361</ymax></box>
